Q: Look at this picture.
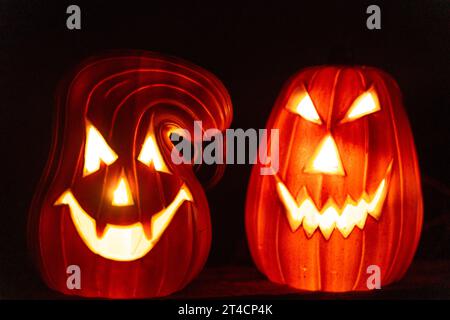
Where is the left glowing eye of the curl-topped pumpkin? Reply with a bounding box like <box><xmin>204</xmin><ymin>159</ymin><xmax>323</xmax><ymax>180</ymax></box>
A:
<box><xmin>83</xmin><ymin>122</ymin><xmax>117</xmax><ymax>176</ymax></box>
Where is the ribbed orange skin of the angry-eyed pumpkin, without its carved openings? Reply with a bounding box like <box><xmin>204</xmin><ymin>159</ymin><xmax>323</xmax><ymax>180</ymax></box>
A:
<box><xmin>245</xmin><ymin>66</ymin><xmax>423</xmax><ymax>292</ymax></box>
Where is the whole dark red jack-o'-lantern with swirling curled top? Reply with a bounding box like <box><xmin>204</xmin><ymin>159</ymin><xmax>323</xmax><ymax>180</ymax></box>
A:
<box><xmin>29</xmin><ymin>52</ymin><xmax>231</xmax><ymax>298</ymax></box>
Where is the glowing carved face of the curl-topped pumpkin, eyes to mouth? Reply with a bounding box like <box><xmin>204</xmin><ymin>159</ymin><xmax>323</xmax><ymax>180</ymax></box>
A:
<box><xmin>55</xmin><ymin>118</ymin><xmax>194</xmax><ymax>261</ymax></box>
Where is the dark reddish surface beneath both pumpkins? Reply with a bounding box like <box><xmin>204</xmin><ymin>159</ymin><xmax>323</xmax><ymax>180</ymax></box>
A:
<box><xmin>0</xmin><ymin>260</ymin><xmax>450</xmax><ymax>300</ymax></box>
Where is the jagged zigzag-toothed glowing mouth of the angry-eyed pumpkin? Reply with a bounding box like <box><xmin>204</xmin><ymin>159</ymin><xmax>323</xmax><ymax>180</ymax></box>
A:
<box><xmin>276</xmin><ymin>162</ymin><xmax>392</xmax><ymax>240</ymax></box>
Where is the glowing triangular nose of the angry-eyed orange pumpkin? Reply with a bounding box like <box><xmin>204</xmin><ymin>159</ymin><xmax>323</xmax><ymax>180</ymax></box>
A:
<box><xmin>304</xmin><ymin>134</ymin><xmax>345</xmax><ymax>176</ymax></box>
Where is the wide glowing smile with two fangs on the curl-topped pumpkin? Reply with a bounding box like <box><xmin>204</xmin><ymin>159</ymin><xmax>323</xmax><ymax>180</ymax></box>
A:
<box><xmin>55</xmin><ymin>185</ymin><xmax>192</xmax><ymax>261</ymax></box>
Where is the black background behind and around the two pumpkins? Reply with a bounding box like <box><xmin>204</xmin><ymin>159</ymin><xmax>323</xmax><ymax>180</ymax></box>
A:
<box><xmin>0</xmin><ymin>0</ymin><xmax>450</xmax><ymax>297</ymax></box>
